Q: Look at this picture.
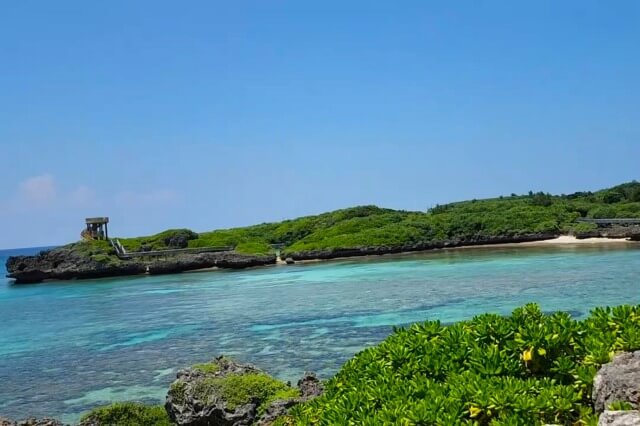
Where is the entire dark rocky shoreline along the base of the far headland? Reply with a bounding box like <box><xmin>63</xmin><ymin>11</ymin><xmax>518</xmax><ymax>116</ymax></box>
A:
<box><xmin>6</xmin><ymin>229</ymin><xmax>640</xmax><ymax>284</ymax></box>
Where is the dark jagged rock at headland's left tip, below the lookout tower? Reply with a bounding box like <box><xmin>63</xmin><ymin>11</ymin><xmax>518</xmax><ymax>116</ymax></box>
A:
<box><xmin>7</xmin><ymin>246</ymin><xmax>276</xmax><ymax>283</ymax></box>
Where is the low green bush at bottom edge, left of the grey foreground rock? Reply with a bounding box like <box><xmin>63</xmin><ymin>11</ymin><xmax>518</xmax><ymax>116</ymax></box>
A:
<box><xmin>81</xmin><ymin>402</ymin><xmax>172</xmax><ymax>426</ymax></box>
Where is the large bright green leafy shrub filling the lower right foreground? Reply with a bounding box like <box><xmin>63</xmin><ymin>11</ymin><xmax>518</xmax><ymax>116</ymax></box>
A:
<box><xmin>288</xmin><ymin>305</ymin><xmax>640</xmax><ymax>426</ymax></box>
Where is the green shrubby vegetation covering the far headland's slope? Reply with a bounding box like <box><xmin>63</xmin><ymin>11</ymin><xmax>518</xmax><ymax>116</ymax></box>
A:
<box><xmin>76</xmin><ymin>182</ymin><xmax>640</xmax><ymax>260</ymax></box>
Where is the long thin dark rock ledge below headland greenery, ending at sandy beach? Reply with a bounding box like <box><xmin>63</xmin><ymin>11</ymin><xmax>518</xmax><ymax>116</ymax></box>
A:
<box><xmin>286</xmin><ymin>233</ymin><xmax>559</xmax><ymax>261</ymax></box>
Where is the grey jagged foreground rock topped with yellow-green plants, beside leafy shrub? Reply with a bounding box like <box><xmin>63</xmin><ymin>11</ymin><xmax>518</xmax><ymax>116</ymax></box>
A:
<box><xmin>165</xmin><ymin>357</ymin><xmax>322</xmax><ymax>426</ymax></box>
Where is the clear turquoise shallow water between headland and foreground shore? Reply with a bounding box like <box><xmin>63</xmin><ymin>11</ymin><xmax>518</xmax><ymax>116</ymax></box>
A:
<box><xmin>0</xmin><ymin>246</ymin><xmax>640</xmax><ymax>422</ymax></box>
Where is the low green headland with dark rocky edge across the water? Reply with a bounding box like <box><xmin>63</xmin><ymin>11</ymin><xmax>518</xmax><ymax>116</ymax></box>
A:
<box><xmin>6</xmin><ymin>181</ymin><xmax>640</xmax><ymax>283</ymax></box>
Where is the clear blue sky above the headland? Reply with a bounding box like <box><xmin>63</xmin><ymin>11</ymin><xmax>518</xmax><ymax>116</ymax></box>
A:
<box><xmin>0</xmin><ymin>0</ymin><xmax>640</xmax><ymax>248</ymax></box>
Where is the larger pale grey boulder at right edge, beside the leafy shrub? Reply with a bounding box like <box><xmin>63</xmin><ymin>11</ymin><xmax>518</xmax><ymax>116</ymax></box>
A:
<box><xmin>592</xmin><ymin>351</ymin><xmax>640</xmax><ymax>413</ymax></box>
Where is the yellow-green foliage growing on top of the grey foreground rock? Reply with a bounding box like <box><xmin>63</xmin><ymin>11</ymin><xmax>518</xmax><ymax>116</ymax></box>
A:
<box><xmin>194</xmin><ymin>373</ymin><xmax>299</xmax><ymax>410</ymax></box>
